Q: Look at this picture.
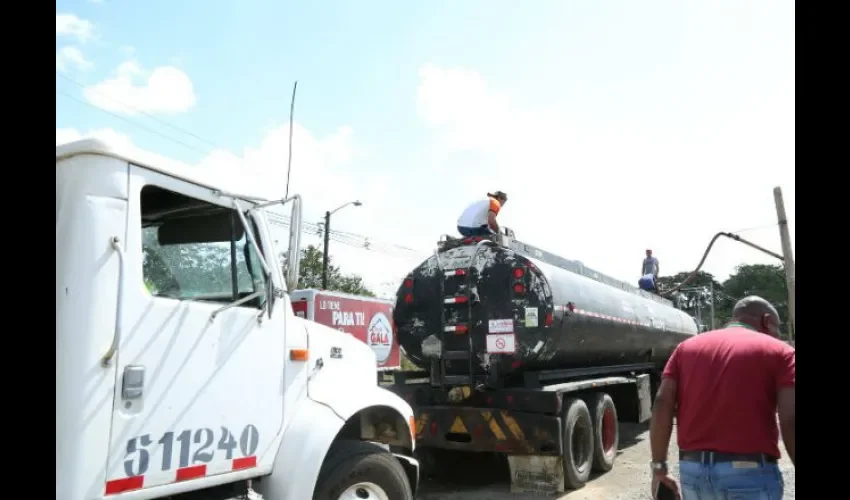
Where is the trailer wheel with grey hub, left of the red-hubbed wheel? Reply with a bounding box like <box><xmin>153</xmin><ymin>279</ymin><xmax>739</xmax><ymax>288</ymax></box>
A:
<box><xmin>563</xmin><ymin>399</ymin><xmax>593</xmax><ymax>489</ymax></box>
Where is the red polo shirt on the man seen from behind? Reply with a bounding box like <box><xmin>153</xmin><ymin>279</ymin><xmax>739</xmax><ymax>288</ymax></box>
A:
<box><xmin>663</xmin><ymin>323</ymin><xmax>795</xmax><ymax>458</ymax></box>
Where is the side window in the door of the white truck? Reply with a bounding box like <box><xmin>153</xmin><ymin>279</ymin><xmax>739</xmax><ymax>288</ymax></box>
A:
<box><xmin>142</xmin><ymin>186</ymin><xmax>265</xmax><ymax>308</ymax></box>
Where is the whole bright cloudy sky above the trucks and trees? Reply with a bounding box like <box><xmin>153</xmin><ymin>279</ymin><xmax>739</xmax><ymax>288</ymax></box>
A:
<box><xmin>56</xmin><ymin>0</ymin><xmax>796</xmax><ymax>295</ymax></box>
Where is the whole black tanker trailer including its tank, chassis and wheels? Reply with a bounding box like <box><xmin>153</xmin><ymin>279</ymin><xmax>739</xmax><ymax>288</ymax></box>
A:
<box><xmin>393</xmin><ymin>235</ymin><xmax>698</xmax><ymax>491</ymax></box>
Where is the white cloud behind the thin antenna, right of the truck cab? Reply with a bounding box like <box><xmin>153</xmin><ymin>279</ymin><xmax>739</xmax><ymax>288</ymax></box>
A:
<box><xmin>199</xmin><ymin>123</ymin><xmax>422</xmax><ymax>294</ymax></box>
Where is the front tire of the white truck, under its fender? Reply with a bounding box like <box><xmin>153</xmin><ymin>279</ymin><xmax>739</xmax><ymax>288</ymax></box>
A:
<box><xmin>313</xmin><ymin>440</ymin><xmax>413</xmax><ymax>500</ymax></box>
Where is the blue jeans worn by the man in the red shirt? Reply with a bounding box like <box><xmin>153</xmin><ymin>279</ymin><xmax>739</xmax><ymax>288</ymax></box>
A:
<box><xmin>679</xmin><ymin>461</ymin><xmax>785</xmax><ymax>500</ymax></box>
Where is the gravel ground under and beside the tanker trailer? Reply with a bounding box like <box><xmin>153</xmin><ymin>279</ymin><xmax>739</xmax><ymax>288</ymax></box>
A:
<box><xmin>418</xmin><ymin>424</ymin><xmax>795</xmax><ymax>500</ymax></box>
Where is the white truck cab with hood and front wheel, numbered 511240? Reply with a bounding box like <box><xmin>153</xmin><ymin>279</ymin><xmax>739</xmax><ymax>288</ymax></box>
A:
<box><xmin>56</xmin><ymin>140</ymin><xmax>419</xmax><ymax>500</ymax></box>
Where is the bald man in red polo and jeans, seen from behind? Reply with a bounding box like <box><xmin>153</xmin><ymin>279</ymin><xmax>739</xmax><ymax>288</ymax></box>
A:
<box><xmin>649</xmin><ymin>296</ymin><xmax>796</xmax><ymax>500</ymax></box>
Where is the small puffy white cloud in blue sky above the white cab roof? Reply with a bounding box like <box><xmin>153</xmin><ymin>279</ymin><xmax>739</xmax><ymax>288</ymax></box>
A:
<box><xmin>83</xmin><ymin>61</ymin><xmax>195</xmax><ymax>115</ymax></box>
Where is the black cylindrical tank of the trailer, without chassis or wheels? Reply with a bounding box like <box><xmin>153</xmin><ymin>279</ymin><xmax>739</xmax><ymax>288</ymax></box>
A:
<box><xmin>393</xmin><ymin>238</ymin><xmax>698</xmax><ymax>382</ymax></box>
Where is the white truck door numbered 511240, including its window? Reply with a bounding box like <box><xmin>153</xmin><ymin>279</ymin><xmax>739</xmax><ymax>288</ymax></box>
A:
<box><xmin>101</xmin><ymin>165</ymin><xmax>289</xmax><ymax>494</ymax></box>
